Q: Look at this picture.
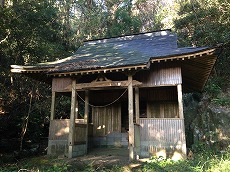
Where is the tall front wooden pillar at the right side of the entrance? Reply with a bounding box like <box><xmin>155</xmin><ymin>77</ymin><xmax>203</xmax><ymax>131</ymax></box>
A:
<box><xmin>128</xmin><ymin>75</ymin><xmax>134</xmax><ymax>161</ymax></box>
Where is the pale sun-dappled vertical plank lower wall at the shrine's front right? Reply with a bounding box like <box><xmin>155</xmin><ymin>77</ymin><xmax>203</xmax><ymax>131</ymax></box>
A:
<box><xmin>140</xmin><ymin>118</ymin><xmax>186</xmax><ymax>157</ymax></box>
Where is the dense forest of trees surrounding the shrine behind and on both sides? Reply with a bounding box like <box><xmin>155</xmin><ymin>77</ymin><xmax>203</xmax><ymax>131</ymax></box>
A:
<box><xmin>0</xmin><ymin>0</ymin><xmax>230</xmax><ymax>153</ymax></box>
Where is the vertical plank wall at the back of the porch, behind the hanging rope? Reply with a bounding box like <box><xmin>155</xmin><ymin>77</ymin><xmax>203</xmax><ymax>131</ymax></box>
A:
<box><xmin>92</xmin><ymin>104</ymin><xmax>121</xmax><ymax>136</ymax></box>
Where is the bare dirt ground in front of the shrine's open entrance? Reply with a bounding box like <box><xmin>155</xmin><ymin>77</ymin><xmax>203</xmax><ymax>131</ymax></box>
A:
<box><xmin>68</xmin><ymin>148</ymin><xmax>145</xmax><ymax>171</ymax></box>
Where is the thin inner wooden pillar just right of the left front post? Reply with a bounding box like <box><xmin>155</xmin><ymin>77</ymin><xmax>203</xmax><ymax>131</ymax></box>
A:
<box><xmin>84</xmin><ymin>90</ymin><xmax>89</xmax><ymax>154</ymax></box>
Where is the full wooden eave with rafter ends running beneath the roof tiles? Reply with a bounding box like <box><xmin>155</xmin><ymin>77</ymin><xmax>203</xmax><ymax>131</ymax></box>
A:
<box><xmin>11</xmin><ymin>47</ymin><xmax>218</xmax><ymax>88</ymax></box>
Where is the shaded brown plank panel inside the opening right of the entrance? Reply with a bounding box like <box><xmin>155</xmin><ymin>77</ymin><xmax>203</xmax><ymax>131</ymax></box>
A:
<box><xmin>147</xmin><ymin>102</ymin><xmax>179</xmax><ymax>118</ymax></box>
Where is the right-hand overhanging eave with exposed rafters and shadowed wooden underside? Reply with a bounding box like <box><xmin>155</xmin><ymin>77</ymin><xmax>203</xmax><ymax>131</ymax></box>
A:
<box><xmin>151</xmin><ymin>47</ymin><xmax>219</xmax><ymax>93</ymax></box>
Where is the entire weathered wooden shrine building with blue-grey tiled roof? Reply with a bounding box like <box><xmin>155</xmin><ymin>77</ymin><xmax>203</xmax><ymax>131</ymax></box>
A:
<box><xmin>11</xmin><ymin>30</ymin><xmax>217</xmax><ymax>160</ymax></box>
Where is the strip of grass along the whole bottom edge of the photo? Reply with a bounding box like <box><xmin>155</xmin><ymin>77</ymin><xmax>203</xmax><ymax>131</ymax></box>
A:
<box><xmin>0</xmin><ymin>152</ymin><xmax>230</xmax><ymax>172</ymax></box>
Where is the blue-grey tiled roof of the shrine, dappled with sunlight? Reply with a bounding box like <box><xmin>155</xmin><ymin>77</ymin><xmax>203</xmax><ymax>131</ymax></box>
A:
<box><xmin>12</xmin><ymin>30</ymin><xmax>207</xmax><ymax>73</ymax></box>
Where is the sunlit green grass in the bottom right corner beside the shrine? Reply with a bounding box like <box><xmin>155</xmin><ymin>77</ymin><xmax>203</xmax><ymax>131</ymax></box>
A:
<box><xmin>141</xmin><ymin>153</ymin><xmax>230</xmax><ymax>172</ymax></box>
